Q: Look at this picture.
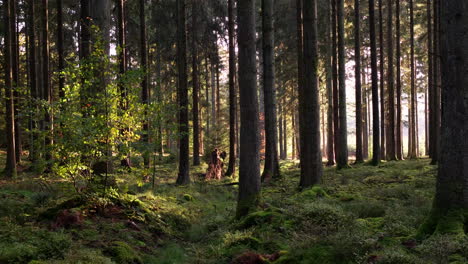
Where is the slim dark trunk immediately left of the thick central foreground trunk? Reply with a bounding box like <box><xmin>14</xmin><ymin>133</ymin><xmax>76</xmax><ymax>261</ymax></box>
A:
<box><xmin>226</xmin><ymin>0</ymin><xmax>236</xmax><ymax>176</ymax></box>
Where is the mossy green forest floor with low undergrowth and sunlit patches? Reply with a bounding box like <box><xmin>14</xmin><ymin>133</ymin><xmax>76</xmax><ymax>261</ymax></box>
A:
<box><xmin>0</xmin><ymin>154</ymin><xmax>468</xmax><ymax>264</ymax></box>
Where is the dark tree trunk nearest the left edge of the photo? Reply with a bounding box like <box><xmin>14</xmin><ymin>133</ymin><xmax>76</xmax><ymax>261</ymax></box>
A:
<box><xmin>3</xmin><ymin>0</ymin><xmax>16</xmax><ymax>178</ymax></box>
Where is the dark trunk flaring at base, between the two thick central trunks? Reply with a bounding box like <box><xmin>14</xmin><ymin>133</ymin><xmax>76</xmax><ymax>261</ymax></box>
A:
<box><xmin>262</xmin><ymin>0</ymin><xmax>280</xmax><ymax>181</ymax></box>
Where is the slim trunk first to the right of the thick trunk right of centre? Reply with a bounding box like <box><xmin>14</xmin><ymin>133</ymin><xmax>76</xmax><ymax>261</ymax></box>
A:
<box><xmin>331</xmin><ymin>0</ymin><xmax>340</xmax><ymax>162</ymax></box>
